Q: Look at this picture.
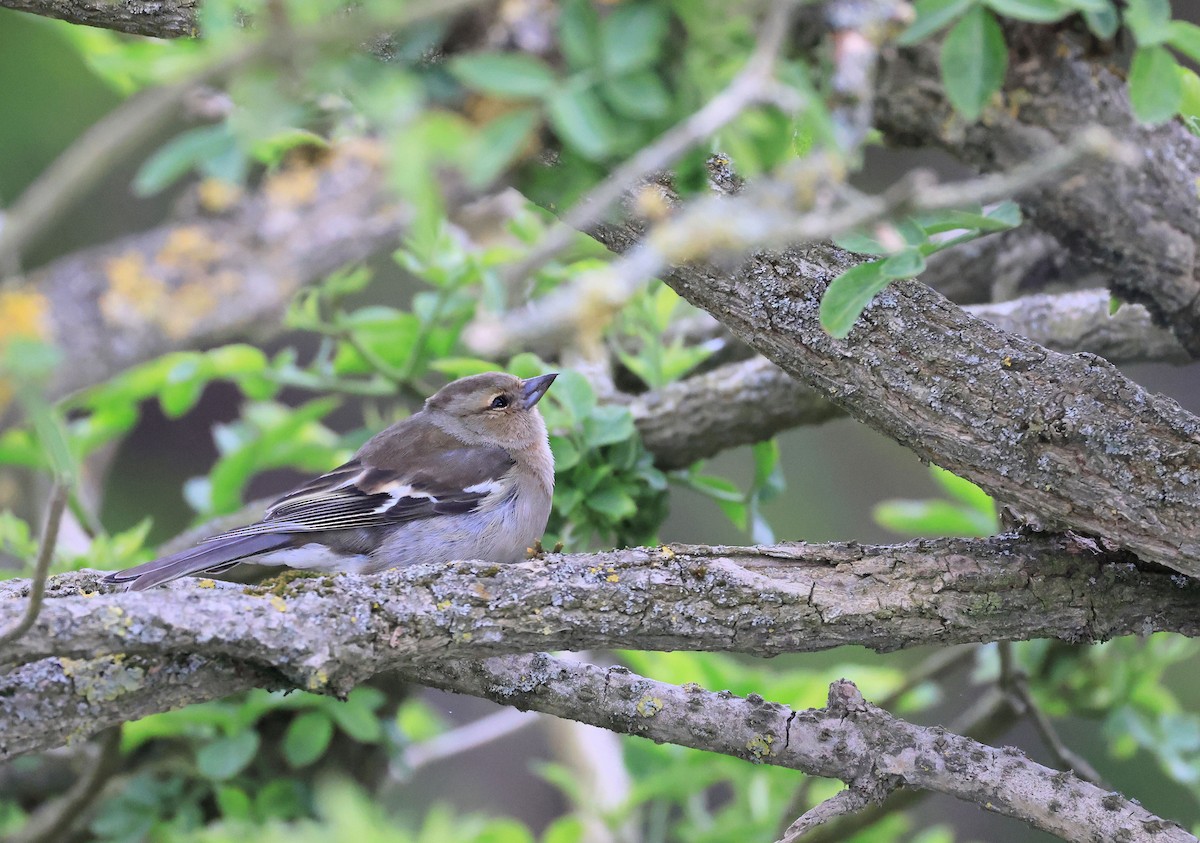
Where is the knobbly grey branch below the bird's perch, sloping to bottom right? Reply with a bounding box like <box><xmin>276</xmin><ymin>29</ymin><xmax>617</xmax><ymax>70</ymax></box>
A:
<box><xmin>0</xmin><ymin>648</ymin><xmax>1196</xmax><ymax>843</ymax></box>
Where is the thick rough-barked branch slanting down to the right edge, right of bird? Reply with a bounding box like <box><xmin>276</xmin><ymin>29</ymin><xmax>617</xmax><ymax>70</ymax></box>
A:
<box><xmin>596</xmin><ymin>218</ymin><xmax>1200</xmax><ymax>575</ymax></box>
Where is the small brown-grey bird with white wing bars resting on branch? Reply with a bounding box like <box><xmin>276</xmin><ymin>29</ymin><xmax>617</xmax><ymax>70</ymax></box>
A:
<box><xmin>104</xmin><ymin>372</ymin><xmax>558</xmax><ymax>591</ymax></box>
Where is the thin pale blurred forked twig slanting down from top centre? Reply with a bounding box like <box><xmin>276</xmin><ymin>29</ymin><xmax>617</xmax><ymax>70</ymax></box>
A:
<box><xmin>505</xmin><ymin>0</ymin><xmax>803</xmax><ymax>282</ymax></box>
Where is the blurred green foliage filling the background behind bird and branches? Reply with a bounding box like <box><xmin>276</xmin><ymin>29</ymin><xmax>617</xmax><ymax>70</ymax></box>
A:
<box><xmin>0</xmin><ymin>0</ymin><xmax>1200</xmax><ymax>843</ymax></box>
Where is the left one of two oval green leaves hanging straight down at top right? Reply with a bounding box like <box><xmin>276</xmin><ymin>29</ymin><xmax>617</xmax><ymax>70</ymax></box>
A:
<box><xmin>942</xmin><ymin>6</ymin><xmax>1008</xmax><ymax>122</ymax></box>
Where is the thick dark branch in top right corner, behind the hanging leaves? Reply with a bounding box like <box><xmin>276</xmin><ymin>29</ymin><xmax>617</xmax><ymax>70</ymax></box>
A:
<box><xmin>876</xmin><ymin>26</ymin><xmax>1200</xmax><ymax>355</ymax></box>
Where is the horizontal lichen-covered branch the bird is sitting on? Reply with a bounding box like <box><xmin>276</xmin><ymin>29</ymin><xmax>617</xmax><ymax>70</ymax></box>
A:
<box><xmin>0</xmin><ymin>537</ymin><xmax>1200</xmax><ymax>710</ymax></box>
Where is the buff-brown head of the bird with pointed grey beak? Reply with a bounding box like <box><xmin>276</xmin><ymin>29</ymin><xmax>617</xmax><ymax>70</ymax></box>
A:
<box><xmin>425</xmin><ymin>372</ymin><xmax>558</xmax><ymax>450</ymax></box>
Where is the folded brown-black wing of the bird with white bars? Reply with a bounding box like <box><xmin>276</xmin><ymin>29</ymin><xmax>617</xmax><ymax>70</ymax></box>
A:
<box><xmin>214</xmin><ymin>417</ymin><xmax>514</xmax><ymax>538</ymax></box>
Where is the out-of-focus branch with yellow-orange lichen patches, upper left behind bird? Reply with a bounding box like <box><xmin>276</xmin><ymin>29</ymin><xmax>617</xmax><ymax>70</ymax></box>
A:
<box><xmin>12</xmin><ymin>142</ymin><xmax>409</xmax><ymax>405</ymax></box>
